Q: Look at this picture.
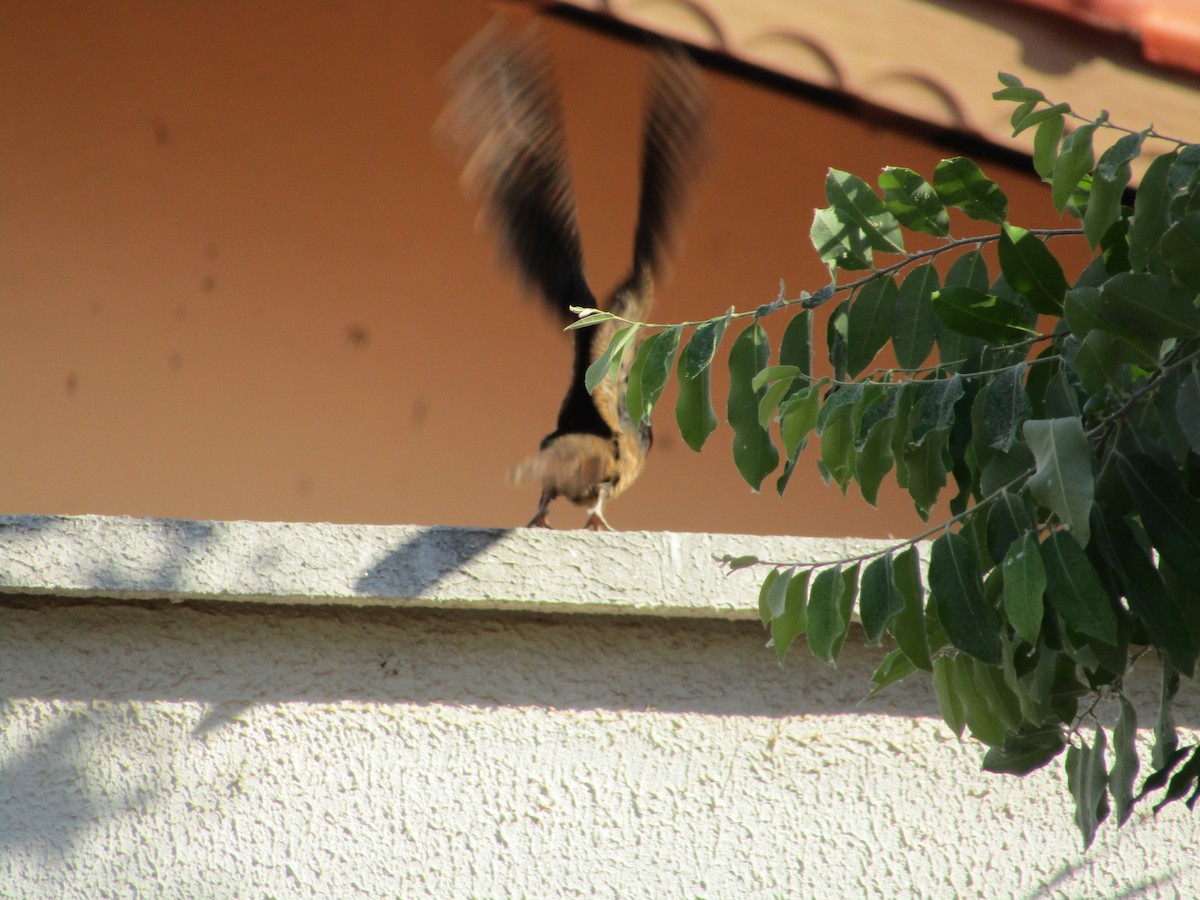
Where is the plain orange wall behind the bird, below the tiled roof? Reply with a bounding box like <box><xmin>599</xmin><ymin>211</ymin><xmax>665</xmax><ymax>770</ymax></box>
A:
<box><xmin>0</xmin><ymin>0</ymin><xmax>1099</xmax><ymax>536</ymax></box>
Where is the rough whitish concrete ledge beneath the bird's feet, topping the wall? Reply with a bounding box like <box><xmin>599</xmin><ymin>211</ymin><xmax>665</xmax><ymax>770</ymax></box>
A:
<box><xmin>0</xmin><ymin>516</ymin><xmax>902</xmax><ymax>619</ymax></box>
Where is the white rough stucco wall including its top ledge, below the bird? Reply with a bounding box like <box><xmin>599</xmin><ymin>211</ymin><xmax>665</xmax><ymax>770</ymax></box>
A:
<box><xmin>0</xmin><ymin>518</ymin><xmax>1200</xmax><ymax>898</ymax></box>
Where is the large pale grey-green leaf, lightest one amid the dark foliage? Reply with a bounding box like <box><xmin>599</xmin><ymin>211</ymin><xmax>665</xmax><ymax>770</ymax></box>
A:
<box><xmin>1022</xmin><ymin>416</ymin><xmax>1096</xmax><ymax>547</ymax></box>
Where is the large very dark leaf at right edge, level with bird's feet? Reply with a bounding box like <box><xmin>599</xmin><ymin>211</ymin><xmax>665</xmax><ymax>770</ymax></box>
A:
<box><xmin>1117</xmin><ymin>454</ymin><xmax>1200</xmax><ymax>584</ymax></box>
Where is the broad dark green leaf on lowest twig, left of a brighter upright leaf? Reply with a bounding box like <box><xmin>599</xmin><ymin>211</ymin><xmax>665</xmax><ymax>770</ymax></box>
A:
<box><xmin>929</xmin><ymin>532</ymin><xmax>1002</xmax><ymax>666</ymax></box>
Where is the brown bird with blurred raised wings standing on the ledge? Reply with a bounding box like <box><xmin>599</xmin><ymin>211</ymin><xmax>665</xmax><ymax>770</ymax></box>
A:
<box><xmin>440</xmin><ymin>20</ymin><xmax>708</xmax><ymax>530</ymax></box>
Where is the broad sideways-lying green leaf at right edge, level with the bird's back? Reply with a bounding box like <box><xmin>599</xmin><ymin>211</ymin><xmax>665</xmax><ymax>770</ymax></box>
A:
<box><xmin>1098</xmin><ymin>272</ymin><xmax>1200</xmax><ymax>341</ymax></box>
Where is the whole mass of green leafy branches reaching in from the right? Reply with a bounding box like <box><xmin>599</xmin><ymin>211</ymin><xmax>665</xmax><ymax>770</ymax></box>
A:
<box><xmin>580</xmin><ymin>74</ymin><xmax>1200</xmax><ymax>844</ymax></box>
